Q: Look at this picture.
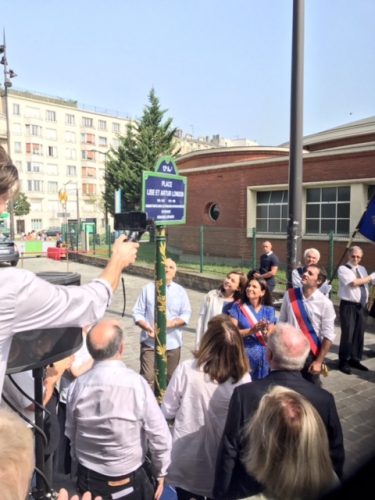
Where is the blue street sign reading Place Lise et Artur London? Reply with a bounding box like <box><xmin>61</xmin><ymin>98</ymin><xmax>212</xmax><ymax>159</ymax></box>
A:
<box><xmin>142</xmin><ymin>156</ymin><xmax>187</xmax><ymax>226</ymax></box>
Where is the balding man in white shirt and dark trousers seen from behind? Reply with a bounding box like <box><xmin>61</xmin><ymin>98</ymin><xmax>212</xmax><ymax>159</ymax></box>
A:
<box><xmin>65</xmin><ymin>320</ymin><xmax>172</xmax><ymax>500</ymax></box>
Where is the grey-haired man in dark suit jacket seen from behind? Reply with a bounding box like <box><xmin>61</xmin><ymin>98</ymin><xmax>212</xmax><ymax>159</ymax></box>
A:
<box><xmin>213</xmin><ymin>323</ymin><xmax>345</xmax><ymax>500</ymax></box>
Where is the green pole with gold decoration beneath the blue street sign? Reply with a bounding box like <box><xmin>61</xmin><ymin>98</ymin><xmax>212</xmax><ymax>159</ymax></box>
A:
<box><xmin>154</xmin><ymin>226</ymin><xmax>167</xmax><ymax>404</ymax></box>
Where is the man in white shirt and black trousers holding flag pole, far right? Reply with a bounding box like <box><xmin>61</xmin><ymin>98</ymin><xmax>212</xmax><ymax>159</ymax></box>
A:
<box><xmin>337</xmin><ymin>246</ymin><xmax>375</xmax><ymax>375</ymax></box>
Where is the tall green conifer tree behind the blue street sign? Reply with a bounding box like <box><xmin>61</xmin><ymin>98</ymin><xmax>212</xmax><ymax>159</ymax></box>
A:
<box><xmin>105</xmin><ymin>88</ymin><xmax>179</xmax><ymax>214</ymax></box>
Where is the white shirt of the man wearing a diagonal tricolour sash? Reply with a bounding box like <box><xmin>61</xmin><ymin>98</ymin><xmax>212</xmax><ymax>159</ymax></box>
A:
<box><xmin>279</xmin><ymin>287</ymin><xmax>336</xmax><ymax>342</ymax></box>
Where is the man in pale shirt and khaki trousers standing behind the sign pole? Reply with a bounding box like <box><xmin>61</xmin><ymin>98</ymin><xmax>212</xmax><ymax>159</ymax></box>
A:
<box><xmin>133</xmin><ymin>259</ymin><xmax>191</xmax><ymax>389</ymax></box>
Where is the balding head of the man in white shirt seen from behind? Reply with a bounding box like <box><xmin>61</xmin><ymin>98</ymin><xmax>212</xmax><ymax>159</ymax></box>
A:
<box><xmin>86</xmin><ymin>319</ymin><xmax>123</xmax><ymax>361</ymax></box>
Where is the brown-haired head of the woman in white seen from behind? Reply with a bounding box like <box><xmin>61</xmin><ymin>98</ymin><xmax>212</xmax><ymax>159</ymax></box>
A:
<box><xmin>194</xmin><ymin>314</ymin><xmax>250</xmax><ymax>384</ymax></box>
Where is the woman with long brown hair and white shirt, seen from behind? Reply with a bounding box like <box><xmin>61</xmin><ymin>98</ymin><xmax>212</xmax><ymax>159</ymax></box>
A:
<box><xmin>161</xmin><ymin>315</ymin><xmax>251</xmax><ymax>500</ymax></box>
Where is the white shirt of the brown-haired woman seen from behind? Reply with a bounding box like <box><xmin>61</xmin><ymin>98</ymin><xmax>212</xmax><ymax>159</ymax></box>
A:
<box><xmin>161</xmin><ymin>359</ymin><xmax>251</xmax><ymax>497</ymax></box>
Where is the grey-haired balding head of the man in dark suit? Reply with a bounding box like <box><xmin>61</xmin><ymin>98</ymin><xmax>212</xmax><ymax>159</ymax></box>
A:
<box><xmin>267</xmin><ymin>323</ymin><xmax>310</xmax><ymax>371</ymax></box>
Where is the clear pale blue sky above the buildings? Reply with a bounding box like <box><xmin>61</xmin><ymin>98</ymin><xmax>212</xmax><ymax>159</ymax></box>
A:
<box><xmin>0</xmin><ymin>0</ymin><xmax>375</xmax><ymax>146</ymax></box>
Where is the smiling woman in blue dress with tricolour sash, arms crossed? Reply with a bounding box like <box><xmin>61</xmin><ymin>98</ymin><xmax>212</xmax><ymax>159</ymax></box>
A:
<box><xmin>229</xmin><ymin>278</ymin><xmax>276</xmax><ymax>380</ymax></box>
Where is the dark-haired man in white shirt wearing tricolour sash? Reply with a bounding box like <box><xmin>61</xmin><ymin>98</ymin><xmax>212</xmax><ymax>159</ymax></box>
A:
<box><xmin>279</xmin><ymin>264</ymin><xmax>336</xmax><ymax>385</ymax></box>
